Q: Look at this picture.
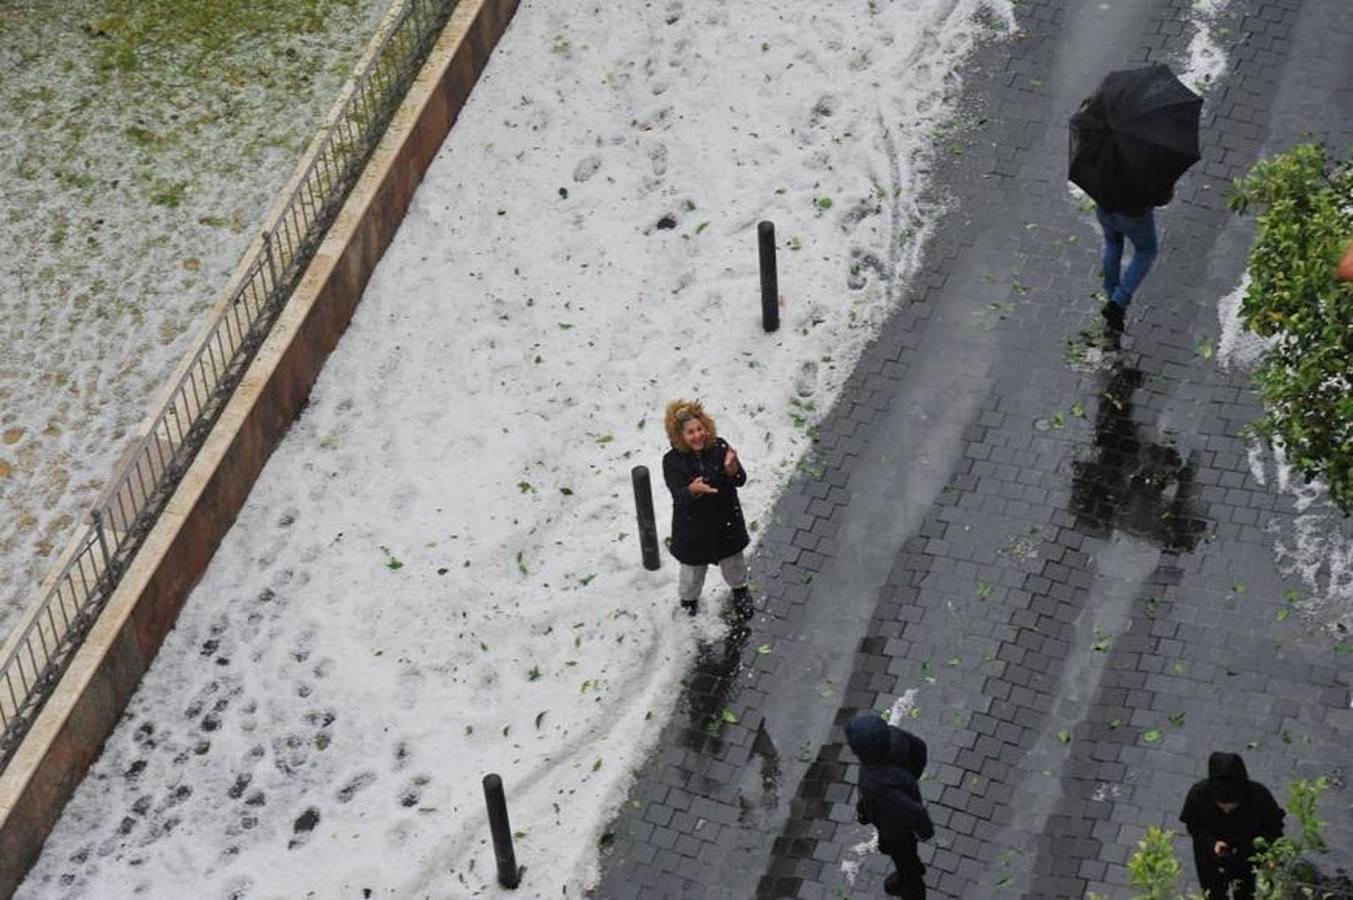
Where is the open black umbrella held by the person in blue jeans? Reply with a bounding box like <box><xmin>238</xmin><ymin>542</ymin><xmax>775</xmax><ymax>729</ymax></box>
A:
<box><xmin>1069</xmin><ymin>64</ymin><xmax>1203</xmax><ymax>212</ymax></box>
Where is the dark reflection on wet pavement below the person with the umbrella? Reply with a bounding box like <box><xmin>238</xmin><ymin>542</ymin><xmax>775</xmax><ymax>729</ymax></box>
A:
<box><xmin>1072</xmin><ymin>363</ymin><xmax>1207</xmax><ymax>552</ymax></box>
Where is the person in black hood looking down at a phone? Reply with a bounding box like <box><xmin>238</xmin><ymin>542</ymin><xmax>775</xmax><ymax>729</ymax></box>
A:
<box><xmin>1180</xmin><ymin>751</ymin><xmax>1287</xmax><ymax>900</ymax></box>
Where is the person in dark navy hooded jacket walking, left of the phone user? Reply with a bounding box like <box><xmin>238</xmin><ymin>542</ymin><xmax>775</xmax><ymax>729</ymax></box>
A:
<box><xmin>846</xmin><ymin>712</ymin><xmax>935</xmax><ymax>900</ymax></box>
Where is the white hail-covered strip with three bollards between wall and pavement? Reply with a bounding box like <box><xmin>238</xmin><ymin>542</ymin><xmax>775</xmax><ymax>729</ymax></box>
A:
<box><xmin>20</xmin><ymin>0</ymin><xmax>1013</xmax><ymax>897</ymax></box>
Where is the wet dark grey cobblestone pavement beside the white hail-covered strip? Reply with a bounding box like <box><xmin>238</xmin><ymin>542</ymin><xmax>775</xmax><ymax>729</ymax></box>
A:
<box><xmin>597</xmin><ymin>0</ymin><xmax>1353</xmax><ymax>899</ymax></box>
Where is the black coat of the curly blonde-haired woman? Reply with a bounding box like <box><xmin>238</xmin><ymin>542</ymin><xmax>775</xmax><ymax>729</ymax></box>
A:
<box><xmin>663</xmin><ymin>437</ymin><xmax>751</xmax><ymax>566</ymax></box>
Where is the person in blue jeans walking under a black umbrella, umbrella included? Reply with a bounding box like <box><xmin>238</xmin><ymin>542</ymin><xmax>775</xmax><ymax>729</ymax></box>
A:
<box><xmin>1069</xmin><ymin>64</ymin><xmax>1203</xmax><ymax>333</ymax></box>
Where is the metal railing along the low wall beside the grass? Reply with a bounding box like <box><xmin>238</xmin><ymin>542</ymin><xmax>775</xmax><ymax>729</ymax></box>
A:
<box><xmin>0</xmin><ymin>0</ymin><xmax>456</xmax><ymax>770</ymax></box>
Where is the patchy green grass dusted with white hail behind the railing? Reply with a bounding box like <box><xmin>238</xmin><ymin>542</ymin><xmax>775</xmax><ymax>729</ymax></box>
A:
<box><xmin>0</xmin><ymin>0</ymin><xmax>388</xmax><ymax>639</ymax></box>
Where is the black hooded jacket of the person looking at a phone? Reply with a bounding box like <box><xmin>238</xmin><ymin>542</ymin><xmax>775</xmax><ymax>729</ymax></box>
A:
<box><xmin>1180</xmin><ymin>751</ymin><xmax>1287</xmax><ymax>870</ymax></box>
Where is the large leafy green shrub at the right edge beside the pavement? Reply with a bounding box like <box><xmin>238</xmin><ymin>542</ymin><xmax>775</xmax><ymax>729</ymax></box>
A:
<box><xmin>1231</xmin><ymin>143</ymin><xmax>1353</xmax><ymax>513</ymax></box>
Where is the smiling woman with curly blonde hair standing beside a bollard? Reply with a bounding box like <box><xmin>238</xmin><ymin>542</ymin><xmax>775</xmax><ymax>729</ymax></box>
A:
<box><xmin>663</xmin><ymin>401</ymin><xmax>752</xmax><ymax>618</ymax></box>
